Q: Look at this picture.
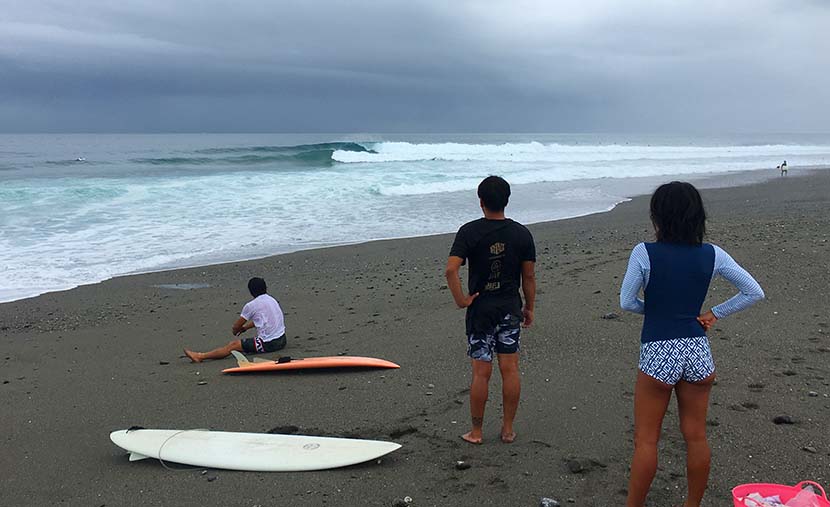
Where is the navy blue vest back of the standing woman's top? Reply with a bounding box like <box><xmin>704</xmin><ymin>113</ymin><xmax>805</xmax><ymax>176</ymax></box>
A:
<box><xmin>640</xmin><ymin>242</ymin><xmax>715</xmax><ymax>343</ymax></box>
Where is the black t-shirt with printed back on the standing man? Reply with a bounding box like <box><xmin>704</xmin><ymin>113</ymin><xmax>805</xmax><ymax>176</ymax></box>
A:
<box><xmin>450</xmin><ymin>218</ymin><xmax>536</xmax><ymax>334</ymax></box>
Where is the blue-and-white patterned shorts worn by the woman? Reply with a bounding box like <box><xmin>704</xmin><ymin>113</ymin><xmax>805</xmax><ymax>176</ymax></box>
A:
<box><xmin>640</xmin><ymin>336</ymin><xmax>715</xmax><ymax>385</ymax></box>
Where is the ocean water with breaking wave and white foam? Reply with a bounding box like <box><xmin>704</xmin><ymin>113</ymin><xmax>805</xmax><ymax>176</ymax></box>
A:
<box><xmin>0</xmin><ymin>134</ymin><xmax>830</xmax><ymax>301</ymax></box>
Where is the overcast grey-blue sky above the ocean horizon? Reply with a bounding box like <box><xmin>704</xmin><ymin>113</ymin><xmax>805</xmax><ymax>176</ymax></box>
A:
<box><xmin>0</xmin><ymin>0</ymin><xmax>830</xmax><ymax>133</ymax></box>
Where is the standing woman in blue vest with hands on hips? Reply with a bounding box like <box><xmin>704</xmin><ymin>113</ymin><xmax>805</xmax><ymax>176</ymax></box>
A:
<box><xmin>620</xmin><ymin>181</ymin><xmax>764</xmax><ymax>507</ymax></box>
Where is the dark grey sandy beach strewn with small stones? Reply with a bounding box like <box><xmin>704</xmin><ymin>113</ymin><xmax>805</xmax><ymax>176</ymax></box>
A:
<box><xmin>0</xmin><ymin>170</ymin><xmax>830</xmax><ymax>507</ymax></box>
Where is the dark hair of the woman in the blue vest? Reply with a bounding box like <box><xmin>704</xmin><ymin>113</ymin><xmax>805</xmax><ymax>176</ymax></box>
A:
<box><xmin>651</xmin><ymin>181</ymin><xmax>706</xmax><ymax>245</ymax></box>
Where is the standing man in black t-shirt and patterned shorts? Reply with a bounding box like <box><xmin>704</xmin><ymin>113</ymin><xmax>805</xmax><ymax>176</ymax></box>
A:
<box><xmin>446</xmin><ymin>176</ymin><xmax>536</xmax><ymax>444</ymax></box>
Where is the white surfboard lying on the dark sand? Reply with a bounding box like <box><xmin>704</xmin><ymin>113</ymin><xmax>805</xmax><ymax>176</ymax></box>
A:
<box><xmin>110</xmin><ymin>429</ymin><xmax>401</xmax><ymax>472</ymax></box>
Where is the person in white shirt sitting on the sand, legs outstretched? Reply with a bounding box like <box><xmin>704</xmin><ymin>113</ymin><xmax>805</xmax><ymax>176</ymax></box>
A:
<box><xmin>184</xmin><ymin>278</ymin><xmax>285</xmax><ymax>363</ymax></box>
